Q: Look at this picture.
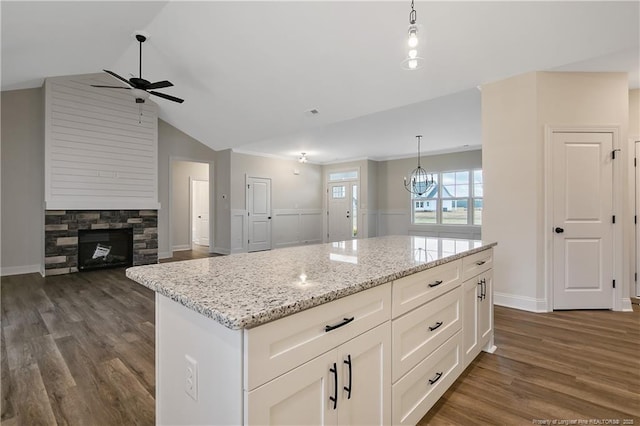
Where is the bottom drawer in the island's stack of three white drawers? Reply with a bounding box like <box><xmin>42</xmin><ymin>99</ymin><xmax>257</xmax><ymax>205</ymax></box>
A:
<box><xmin>391</xmin><ymin>333</ymin><xmax>462</xmax><ymax>425</ymax></box>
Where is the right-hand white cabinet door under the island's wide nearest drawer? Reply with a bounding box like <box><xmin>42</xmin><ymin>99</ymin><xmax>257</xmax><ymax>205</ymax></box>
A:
<box><xmin>338</xmin><ymin>321</ymin><xmax>391</xmax><ymax>426</ymax></box>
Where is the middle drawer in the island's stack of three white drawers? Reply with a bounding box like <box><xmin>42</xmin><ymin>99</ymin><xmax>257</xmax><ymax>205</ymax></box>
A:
<box><xmin>391</xmin><ymin>287</ymin><xmax>462</xmax><ymax>383</ymax></box>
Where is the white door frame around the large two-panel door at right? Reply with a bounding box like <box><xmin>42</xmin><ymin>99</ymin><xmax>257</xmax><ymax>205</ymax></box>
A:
<box><xmin>542</xmin><ymin>124</ymin><xmax>631</xmax><ymax>312</ymax></box>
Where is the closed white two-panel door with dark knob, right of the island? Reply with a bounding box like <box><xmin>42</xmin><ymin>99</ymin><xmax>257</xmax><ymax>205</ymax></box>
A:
<box><xmin>551</xmin><ymin>132</ymin><xmax>613</xmax><ymax>309</ymax></box>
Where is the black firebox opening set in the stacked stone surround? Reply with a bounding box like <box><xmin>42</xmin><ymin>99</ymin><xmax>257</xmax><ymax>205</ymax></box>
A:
<box><xmin>78</xmin><ymin>228</ymin><xmax>133</xmax><ymax>271</ymax></box>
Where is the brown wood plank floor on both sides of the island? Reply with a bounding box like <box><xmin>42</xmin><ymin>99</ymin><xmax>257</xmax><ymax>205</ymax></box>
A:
<box><xmin>0</xmin><ymin>253</ymin><xmax>640</xmax><ymax>426</ymax></box>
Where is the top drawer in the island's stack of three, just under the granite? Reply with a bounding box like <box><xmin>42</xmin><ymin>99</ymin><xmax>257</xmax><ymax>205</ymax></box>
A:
<box><xmin>392</xmin><ymin>260</ymin><xmax>462</xmax><ymax>318</ymax></box>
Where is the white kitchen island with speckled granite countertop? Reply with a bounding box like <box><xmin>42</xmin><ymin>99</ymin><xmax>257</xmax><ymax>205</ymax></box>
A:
<box><xmin>127</xmin><ymin>236</ymin><xmax>495</xmax><ymax>424</ymax></box>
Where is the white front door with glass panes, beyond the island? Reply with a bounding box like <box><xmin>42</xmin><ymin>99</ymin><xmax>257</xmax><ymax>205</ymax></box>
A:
<box><xmin>327</xmin><ymin>182</ymin><xmax>358</xmax><ymax>242</ymax></box>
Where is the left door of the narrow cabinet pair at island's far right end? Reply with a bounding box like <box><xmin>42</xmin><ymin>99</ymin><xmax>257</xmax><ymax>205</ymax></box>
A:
<box><xmin>462</xmin><ymin>277</ymin><xmax>482</xmax><ymax>367</ymax></box>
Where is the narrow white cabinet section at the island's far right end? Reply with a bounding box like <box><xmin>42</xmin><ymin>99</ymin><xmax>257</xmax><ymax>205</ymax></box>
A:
<box><xmin>462</xmin><ymin>250</ymin><xmax>495</xmax><ymax>367</ymax></box>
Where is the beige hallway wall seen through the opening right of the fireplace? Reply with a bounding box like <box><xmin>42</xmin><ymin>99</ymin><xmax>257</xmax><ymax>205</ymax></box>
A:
<box><xmin>171</xmin><ymin>161</ymin><xmax>209</xmax><ymax>250</ymax></box>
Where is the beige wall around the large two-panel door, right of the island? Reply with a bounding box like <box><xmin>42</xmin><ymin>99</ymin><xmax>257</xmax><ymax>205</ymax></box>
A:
<box><xmin>482</xmin><ymin>72</ymin><xmax>628</xmax><ymax>310</ymax></box>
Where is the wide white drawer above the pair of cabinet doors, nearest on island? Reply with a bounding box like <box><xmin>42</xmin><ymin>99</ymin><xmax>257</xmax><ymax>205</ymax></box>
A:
<box><xmin>244</xmin><ymin>283</ymin><xmax>391</xmax><ymax>390</ymax></box>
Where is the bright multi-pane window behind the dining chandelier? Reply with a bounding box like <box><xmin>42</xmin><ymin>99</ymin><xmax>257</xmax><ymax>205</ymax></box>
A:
<box><xmin>411</xmin><ymin>169</ymin><xmax>483</xmax><ymax>225</ymax></box>
